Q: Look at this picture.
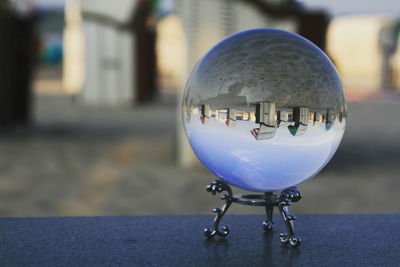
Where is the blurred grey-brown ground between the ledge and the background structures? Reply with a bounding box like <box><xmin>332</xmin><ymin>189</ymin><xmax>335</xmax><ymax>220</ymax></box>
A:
<box><xmin>0</xmin><ymin>88</ymin><xmax>400</xmax><ymax>217</ymax></box>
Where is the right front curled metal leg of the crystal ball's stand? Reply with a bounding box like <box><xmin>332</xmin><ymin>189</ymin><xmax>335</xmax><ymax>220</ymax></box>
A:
<box><xmin>278</xmin><ymin>187</ymin><xmax>301</xmax><ymax>248</ymax></box>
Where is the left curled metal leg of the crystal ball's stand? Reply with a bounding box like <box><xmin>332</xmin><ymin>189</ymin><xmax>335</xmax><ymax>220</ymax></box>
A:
<box><xmin>204</xmin><ymin>180</ymin><xmax>232</xmax><ymax>238</ymax></box>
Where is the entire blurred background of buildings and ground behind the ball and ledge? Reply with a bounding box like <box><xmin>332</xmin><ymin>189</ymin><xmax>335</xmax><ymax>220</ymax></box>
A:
<box><xmin>0</xmin><ymin>0</ymin><xmax>400</xmax><ymax>217</ymax></box>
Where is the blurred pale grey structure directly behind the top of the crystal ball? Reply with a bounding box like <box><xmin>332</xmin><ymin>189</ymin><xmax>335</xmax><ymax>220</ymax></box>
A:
<box><xmin>175</xmin><ymin>0</ymin><xmax>298</xmax><ymax>85</ymax></box>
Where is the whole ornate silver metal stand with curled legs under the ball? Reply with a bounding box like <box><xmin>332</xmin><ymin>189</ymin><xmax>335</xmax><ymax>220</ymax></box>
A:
<box><xmin>204</xmin><ymin>180</ymin><xmax>301</xmax><ymax>248</ymax></box>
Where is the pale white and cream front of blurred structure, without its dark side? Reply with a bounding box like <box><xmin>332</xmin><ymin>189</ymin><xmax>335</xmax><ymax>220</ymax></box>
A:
<box><xmin>63</xmin><ymin>0</ymin><xmax>135</xmax><ymax>106</ymax></box>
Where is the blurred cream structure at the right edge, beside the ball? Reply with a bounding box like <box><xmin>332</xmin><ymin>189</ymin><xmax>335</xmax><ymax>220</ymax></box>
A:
<box><xmin>327</xmin><ymin>15</ymin><xmax>400</xmax><ymax>97</ymax></box>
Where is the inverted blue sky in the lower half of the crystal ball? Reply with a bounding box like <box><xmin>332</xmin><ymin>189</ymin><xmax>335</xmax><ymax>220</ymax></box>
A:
<box><xmin>184</xmin><ymin>114</ymin><xmax>345</xmax><ymax>192</ymax></box>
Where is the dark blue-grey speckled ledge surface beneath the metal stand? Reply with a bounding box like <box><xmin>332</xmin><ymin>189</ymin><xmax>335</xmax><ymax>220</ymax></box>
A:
<box><xmin>0</xmin><ymin>215</ymin><xmax>400</xmax><ymax>266</ymax></box>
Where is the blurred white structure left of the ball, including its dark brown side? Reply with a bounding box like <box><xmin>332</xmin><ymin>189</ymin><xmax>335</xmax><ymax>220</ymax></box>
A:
<box><xmin>63</xmin><ymin>0</ymin><xmax>156</xmax><ymax>106</ymax></box>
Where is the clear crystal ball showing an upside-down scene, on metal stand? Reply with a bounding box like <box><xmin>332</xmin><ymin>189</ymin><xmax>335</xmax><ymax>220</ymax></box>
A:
<box><xmin>182</xmin><ymin>28</ymin><xmax>347</xmax><ymax>192</ymax></box>
